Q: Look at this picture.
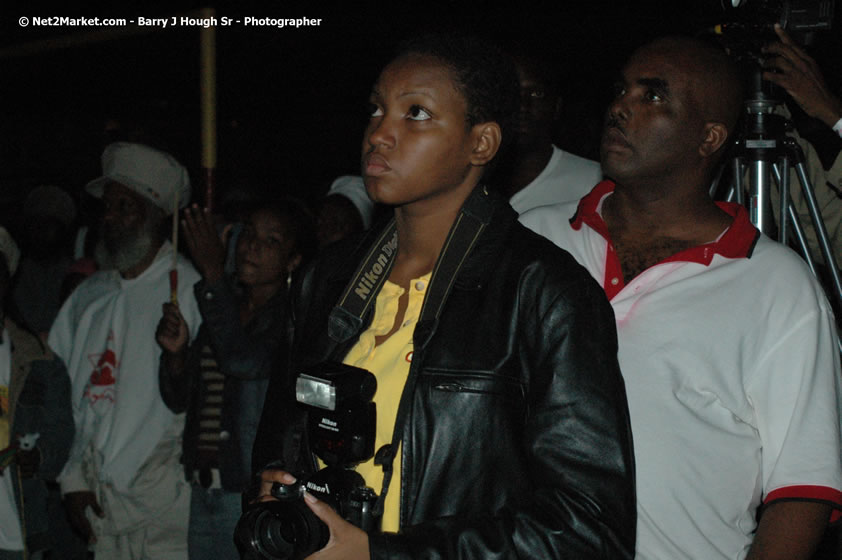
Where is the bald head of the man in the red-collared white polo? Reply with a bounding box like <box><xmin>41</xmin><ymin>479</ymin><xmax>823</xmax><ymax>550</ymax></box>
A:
<box><xmin>600</xmin><ymin>37</ymin><xmax>742</xmax><ymax>191</ymax></box>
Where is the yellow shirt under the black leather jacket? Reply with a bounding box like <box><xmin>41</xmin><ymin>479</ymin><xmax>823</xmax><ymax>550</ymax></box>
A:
<box><xmin>344</xmin><ymin>273</ymin><xmax>432</xmax><ymax>532</ymax></box>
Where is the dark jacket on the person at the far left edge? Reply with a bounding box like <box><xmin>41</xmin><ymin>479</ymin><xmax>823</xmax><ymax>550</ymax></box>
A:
<box><xmin>4</xmin><ymin>320</ymin><xmax>75</xmax><ymax>552</ymax></box>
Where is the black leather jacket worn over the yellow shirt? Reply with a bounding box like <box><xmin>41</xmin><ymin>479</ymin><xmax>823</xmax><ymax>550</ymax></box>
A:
<box><xmin>253</xmin><ymin>189</ymin><xmax>636</xmax><ymax>560</ymax></box>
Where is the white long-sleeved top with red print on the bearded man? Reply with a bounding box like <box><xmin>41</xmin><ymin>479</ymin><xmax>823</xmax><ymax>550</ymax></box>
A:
<box><xmin>48</xmin><ymin>242</ymin><xmax>201</xmax><ymax>493</ymax></box>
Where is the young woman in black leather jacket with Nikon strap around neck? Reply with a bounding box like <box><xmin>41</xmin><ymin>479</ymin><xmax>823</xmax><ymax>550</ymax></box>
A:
<box><xmin>248</xmin><ymin>36</ymin><xmax>635</xmax><ymax>559</ymax></box>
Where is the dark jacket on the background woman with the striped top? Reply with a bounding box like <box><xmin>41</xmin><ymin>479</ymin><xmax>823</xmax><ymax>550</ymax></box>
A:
<box><xmin>159</xmin><ymin>280</ymin><xmax>288</xmax><ymax>492</ymax></box>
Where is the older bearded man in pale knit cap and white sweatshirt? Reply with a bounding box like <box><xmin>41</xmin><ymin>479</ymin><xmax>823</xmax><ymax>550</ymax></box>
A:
<box><xmin>48</xmin><ymin>142</ymin><xmax>201</xmax><ymax>560</ymax></box>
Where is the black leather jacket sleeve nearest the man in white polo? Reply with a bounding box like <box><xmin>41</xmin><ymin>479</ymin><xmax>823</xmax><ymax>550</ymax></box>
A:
<box><xmin>370</xmin><ymin>265</ymin><xmax>636</xmax><ymax>560</ymax></box>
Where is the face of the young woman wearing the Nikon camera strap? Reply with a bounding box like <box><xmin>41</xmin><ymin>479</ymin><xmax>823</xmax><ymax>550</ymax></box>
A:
<box><xmin>362</xmin><ymin>55</ymin><xmax>481</xmax><ymax>212</ymax></box>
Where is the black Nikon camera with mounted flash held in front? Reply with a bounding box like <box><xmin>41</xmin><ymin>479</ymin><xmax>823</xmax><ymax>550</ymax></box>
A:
<box><xmin>234</xmin><ymin>362</ymin><xmax>380</xmax><ymax>560</ymax></box>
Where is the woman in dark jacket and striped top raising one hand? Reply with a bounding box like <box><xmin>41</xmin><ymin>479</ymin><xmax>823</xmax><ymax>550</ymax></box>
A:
<box><xmin>157</xmin><ymin>199</ymin><xmax>315</xmax><ymax>559</ymax></box>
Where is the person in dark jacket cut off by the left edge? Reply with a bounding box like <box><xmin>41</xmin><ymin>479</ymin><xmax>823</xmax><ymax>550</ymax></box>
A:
<box><xmin>0</xmin><ymin>227</ymin><xmax>75</xmax><ymax>560</ymax></box>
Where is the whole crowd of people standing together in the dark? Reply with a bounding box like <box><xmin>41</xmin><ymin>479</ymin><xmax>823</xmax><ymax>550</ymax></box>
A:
<box><xmin>0</xmin><ymin>19</ymin><xmax>842</xmax><ymax>560</ymax></box>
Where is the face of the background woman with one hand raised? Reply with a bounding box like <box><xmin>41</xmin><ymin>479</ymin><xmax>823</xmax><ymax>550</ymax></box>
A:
<box><xmin>236</xmin><ymin>210</ymin><xmax>297</xmax><ymax>286</ymax></box>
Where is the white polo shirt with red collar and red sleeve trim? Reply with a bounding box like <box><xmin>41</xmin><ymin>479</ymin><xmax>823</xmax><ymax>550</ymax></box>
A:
<box><xmin>521</xmin><ymin>181</ymin><xmax>842</xmax><ymax>560</ymax></box>
